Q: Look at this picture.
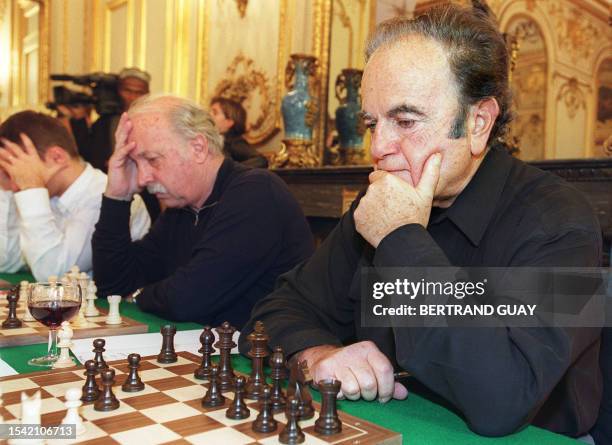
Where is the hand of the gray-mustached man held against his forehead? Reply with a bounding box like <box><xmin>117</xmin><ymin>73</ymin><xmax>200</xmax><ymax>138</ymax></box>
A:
<box><xmin>104</xmin><ymin>113</ymin><xmax>140</xmax><ymax>201</ymax></box>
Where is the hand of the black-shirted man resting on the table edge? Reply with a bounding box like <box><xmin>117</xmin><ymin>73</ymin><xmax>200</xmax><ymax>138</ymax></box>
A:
<box><xmin>297</xmin><ymin>341</ymin><xmax>408</xmax><ymax>402</ymax></box>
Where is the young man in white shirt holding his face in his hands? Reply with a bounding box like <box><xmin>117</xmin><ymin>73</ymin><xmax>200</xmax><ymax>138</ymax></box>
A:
<box><xmin>0</xmin><ymin>111</ymin><xmax>151</xmax><ymax>281</ymax></box>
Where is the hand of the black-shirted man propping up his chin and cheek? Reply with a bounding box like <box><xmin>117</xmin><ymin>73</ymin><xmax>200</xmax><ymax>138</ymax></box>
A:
<box><xmin>353</xmin><ymin>153</ymin><xmax>441</xmax><ymax>248</ymax></box>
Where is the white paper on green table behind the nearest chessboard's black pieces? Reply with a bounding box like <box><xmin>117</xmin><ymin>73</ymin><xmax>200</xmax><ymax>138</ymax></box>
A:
<box><xmin>70</xmin><ymin>329</ymin><xmax>240</xmax><ymax>363</ymax></box>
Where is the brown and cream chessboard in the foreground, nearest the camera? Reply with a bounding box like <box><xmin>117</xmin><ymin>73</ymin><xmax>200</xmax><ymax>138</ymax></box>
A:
<box><xmin>0</xmin><ymin>352</ymin><xmax>402</xmax><ymax>445</ymax></box>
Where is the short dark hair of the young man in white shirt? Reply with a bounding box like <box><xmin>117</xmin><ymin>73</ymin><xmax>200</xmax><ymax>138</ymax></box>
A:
<box><xmin>0</xmin><ymin>110</ymin><xmax>79</xmax><ymax>158</ymax></box>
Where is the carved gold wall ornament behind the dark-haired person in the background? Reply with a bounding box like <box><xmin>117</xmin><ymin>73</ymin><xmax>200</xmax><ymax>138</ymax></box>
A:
<box><xmin>214</xmin><ymin>54</ymin><xmax>278</xmax><ymax>144</ymax></box>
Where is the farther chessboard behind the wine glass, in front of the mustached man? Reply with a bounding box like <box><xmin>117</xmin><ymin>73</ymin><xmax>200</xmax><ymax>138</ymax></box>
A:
<box><xmin>0</xmin><ymin>295</ymin><xmax>149</xmax><ymax>347</ymax></box>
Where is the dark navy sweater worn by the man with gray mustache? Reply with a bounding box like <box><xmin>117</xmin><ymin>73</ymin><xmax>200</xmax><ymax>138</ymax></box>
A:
<box><xmin>92</xmin><ymin>159</ymin><xmax>314</xmax><ymax>328</ymax></box>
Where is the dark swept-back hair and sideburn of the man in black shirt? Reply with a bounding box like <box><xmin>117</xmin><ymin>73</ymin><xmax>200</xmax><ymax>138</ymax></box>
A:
<box><xmin>366</xmin><ymin>2</ymin><xmax>512</xmax><ymax>144</ymax></box>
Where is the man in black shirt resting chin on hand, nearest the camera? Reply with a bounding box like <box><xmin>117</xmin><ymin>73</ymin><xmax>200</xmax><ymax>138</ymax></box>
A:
<box><xmin>241</xmin><ymin>5</ymin><xmax>601</xmax><ymax>436</ymax></box>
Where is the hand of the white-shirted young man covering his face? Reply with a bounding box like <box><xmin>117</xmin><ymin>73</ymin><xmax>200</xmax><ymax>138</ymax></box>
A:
<box><xmin>0</xmin><ymin>133</ymin><xmax>62</xmax><ymax>190</ymax></box>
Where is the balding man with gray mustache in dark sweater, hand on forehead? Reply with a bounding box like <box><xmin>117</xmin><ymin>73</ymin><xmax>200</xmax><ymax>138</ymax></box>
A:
<box><xmin>92</xmin><ymin>96</ymin><xmax>314</xmax><ymax>327</ymax></box>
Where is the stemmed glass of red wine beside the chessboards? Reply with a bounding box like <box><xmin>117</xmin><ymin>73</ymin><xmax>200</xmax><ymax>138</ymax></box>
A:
<box><xmin>28</xmin><ymin>281</ymin><xmax>82</xmax><ymax>366</ymax></box>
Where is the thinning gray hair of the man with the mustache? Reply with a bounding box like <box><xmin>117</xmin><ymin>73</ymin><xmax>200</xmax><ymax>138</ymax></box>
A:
<box><xmin>128</xmin><ymin>94</ymin><xmax>223</xmax><ymax>155</ymax></box>
